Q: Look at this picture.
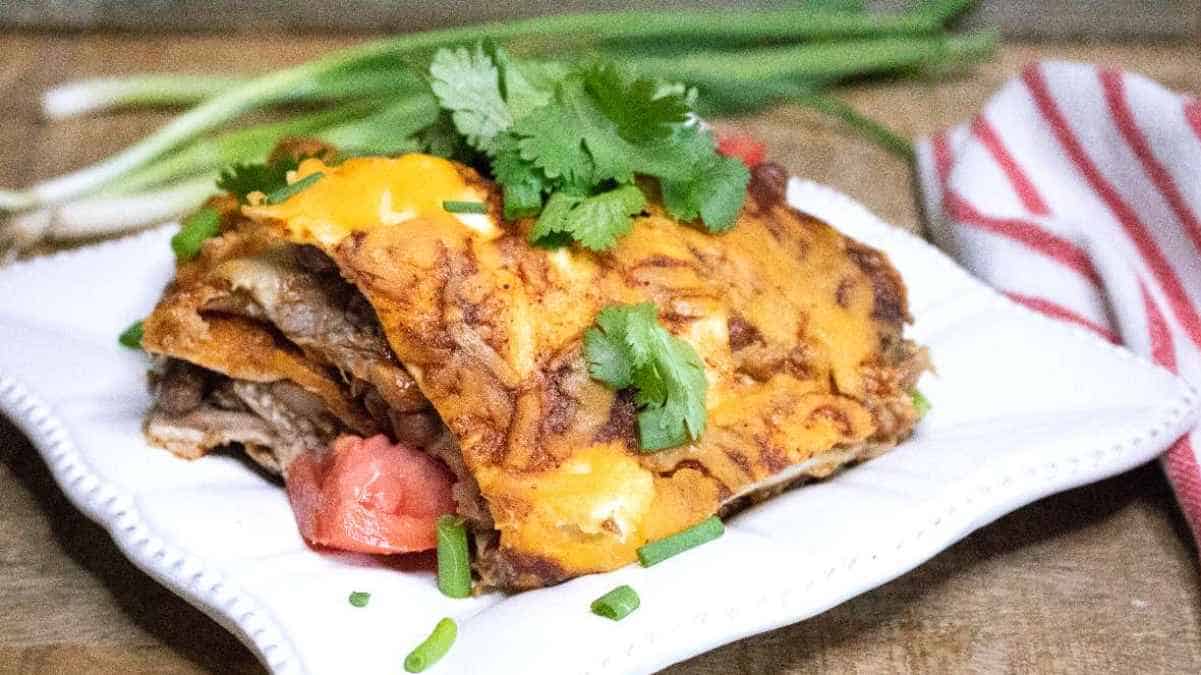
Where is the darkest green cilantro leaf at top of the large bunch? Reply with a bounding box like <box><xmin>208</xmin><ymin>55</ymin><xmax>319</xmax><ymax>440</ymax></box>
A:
<box><xmin>584</xmin><ymin>62</ymin><xmax>688</xmax><ymax>143</ymax></box>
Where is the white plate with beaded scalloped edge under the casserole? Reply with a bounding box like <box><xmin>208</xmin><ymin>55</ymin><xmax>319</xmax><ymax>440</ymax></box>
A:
<box><xmin>0</xmin><ymin>180</ymin><xmax>1197</xmax><ymax>675</ymax></box>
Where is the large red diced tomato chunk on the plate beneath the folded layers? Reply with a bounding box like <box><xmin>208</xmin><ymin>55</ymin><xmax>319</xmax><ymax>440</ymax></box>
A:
<box><xmin>285</xmin><ymin>435</ymin><xmax>454</xmax><ymax>554</ymax></box>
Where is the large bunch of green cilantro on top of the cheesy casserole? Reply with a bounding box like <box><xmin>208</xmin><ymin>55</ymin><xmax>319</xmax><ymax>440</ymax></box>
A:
<box><xmin>430</xmin><ymin>46</ymin><xmax>749</xmax><ymax>251</ymax></box>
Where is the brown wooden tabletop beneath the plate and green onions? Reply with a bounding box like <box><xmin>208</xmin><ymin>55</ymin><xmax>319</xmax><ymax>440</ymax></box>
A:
<box><xmin>0</xmin><ymin>34</ymin><xmax>1201</xmax><ymax>675</ymax></box>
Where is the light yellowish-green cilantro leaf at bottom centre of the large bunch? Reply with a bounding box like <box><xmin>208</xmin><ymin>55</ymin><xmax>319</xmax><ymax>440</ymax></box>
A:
<box><xmin>530</xmin><ymin>185</ymin><xmax>646</xmax><ymax>251</ymax></box>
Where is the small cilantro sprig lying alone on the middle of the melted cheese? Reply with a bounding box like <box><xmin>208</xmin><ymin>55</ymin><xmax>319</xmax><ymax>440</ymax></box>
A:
<box><xmin>584</xmin><ymin>303</ymin><xmax>709</xmax><ymax>452</ymax></box>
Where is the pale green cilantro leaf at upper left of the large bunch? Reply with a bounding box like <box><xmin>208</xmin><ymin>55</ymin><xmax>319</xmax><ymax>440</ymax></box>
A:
<box><xmin>430</xmin><ymin>44</ymin><xmax>513</xmax><ymax>153</ymax></box>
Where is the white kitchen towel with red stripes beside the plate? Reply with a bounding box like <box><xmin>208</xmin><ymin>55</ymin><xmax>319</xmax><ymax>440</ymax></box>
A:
<box><xmin>918</xmin><ymin>62</ymin><xmax>1201</xmax><ymax>542</ymax></box>
